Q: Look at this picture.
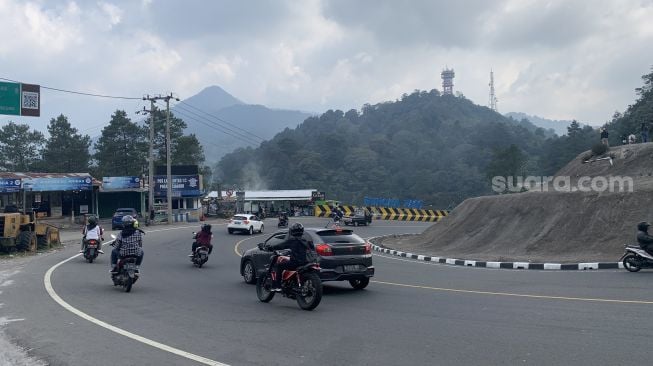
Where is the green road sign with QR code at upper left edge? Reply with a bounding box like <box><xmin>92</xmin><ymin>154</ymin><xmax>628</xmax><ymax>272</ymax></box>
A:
<box><xmin>0</xmin><ymin>82</ymin><xmax>41</xmax><ymax>117</ymax></box>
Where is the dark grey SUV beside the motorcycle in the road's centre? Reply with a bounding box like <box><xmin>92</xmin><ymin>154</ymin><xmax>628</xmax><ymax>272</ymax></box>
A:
<box><xmin>240</xmin><ymin>228</ymin><xmax>374</xmax><ymax>289</ymax></box>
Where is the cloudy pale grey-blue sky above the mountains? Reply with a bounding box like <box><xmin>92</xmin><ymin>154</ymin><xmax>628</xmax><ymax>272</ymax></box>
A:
<box><xmin>0</xmin><ymin>0</ymin><xmax>653</xmax><ymax>136</ymax></box>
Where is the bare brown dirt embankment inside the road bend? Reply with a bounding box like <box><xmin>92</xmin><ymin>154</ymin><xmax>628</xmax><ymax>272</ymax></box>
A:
<box><xmin>379</xmin><ymin>143</ymin><xmax>653</xmax><ymax>263</ymax></box>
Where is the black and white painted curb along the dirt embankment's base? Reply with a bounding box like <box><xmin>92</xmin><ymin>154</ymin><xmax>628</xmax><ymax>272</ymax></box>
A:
<box><xmin>368</xmin><ymin>234</ymin><xmax>624</xmax><ymax>271</ymax></box>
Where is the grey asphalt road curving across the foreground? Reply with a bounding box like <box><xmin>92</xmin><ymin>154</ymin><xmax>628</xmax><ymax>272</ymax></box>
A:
<box><xmin>0</xmin><ymin>218</ymin><xmax>653</xmax><ymax>366</ymax></box>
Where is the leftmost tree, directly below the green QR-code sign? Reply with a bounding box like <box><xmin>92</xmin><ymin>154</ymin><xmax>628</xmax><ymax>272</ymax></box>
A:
<box><xmin>0</xmin><ymin>122</ymin><xmax>45</xmax><ymax>172</ymax></box>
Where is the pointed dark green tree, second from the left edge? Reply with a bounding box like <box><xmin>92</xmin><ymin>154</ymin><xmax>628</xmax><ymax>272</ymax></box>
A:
<box><xmin>39</xmin><ymin>114</ymin><xmax>91</xmax><ymax>173</ymax></box>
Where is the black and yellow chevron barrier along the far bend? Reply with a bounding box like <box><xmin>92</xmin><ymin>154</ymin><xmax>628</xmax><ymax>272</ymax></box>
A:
<box><xmin>314</xmin><ymin>205</ymin><xmax>449</xmax><ymax>222</ymax></box>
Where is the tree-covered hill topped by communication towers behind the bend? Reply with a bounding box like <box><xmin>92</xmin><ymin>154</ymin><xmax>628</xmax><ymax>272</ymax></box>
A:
<box><xmin>217</xmin><ymin>90</ymin><xmax>598</xmax><ymax>208</ymax></box>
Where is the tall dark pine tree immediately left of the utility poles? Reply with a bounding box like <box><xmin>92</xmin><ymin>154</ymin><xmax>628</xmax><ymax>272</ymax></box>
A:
<box><xmin>94</xmin><ymin>110</ymin><xmax>149</xmax><ymax>176</ymax></box>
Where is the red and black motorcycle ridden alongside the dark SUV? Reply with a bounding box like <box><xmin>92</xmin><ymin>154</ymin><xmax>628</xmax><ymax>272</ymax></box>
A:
<box><xmin>256</xmin><ymin>243</ymin><xmax>322</xmax><ymax>310</ymax></box>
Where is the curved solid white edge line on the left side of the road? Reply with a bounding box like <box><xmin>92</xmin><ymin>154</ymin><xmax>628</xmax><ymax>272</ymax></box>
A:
<box><xmin>43</xmin><ymin>249</ymin><xmax>229</xmax><ymax>366</ymax></box>
